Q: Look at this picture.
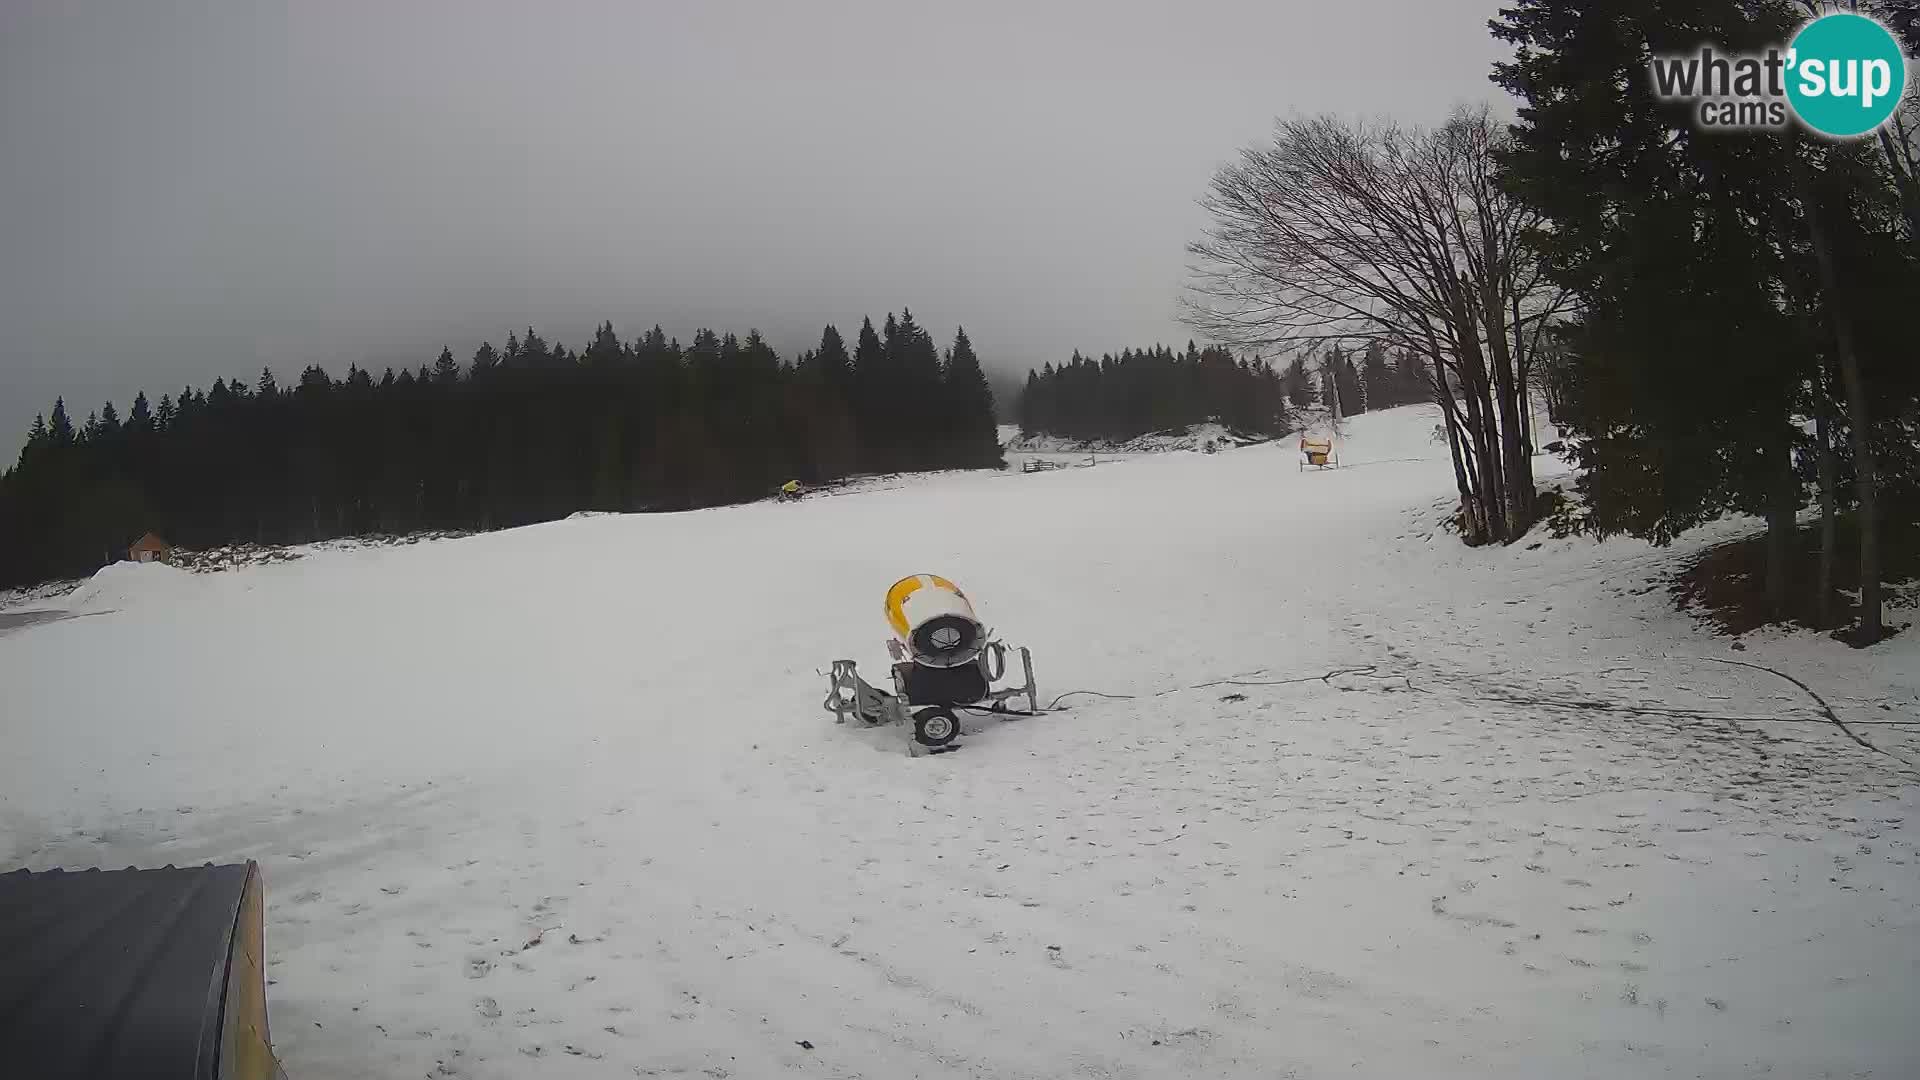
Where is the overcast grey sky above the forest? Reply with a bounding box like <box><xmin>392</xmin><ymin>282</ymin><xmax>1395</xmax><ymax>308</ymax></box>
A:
<box><xmin>0</xmin><ymin>0</ymin><xmax>1501</xmax><ymax>441</ymax></box>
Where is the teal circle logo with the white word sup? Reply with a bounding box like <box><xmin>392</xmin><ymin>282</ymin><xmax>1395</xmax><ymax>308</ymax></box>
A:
<box><xmin>1788</xmin><ymin>12</ymin><xmax>1907</xmax><ymax>138</ymax></box>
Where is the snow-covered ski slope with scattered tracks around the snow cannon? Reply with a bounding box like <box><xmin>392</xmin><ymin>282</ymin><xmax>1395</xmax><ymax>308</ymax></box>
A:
<box><xmin>0</xmin><ymin>409</ymin><xmax>1920</xmax><ymax>1080</ymax></box>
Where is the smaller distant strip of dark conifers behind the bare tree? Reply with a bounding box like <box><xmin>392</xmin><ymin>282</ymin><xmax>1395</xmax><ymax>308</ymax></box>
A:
<box><xmin>1016</xmin><ymin>342</ymin><xmax>1432</xmax><ymax>442</ymax></box>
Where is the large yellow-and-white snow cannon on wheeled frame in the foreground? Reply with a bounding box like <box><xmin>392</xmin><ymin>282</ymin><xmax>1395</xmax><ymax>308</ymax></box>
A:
<box><xmin>824</xmin><ymin>575</ymin><xmax>1041</xmax><ymax>757</ymax></box>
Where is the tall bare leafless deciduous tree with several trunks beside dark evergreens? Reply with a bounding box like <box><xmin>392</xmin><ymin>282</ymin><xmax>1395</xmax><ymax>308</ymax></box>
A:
<box><xmin>1187</xmin><ymin>108</ymin><xmax>1565</xmax><ymax>544</ymax></box>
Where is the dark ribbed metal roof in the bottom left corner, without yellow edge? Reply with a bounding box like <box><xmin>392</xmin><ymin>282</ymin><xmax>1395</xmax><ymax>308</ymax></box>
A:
<box><xmin>0</xmin><ymin>863</ymin><xmax>248</xmax><ymax>1080</ymax></box>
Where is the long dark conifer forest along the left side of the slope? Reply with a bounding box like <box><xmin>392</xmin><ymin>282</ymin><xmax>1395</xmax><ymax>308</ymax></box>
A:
<box><xmin>0</xmin><ymin>311</ymin><xmax>1002</xmax><ymax>586</ymax></box>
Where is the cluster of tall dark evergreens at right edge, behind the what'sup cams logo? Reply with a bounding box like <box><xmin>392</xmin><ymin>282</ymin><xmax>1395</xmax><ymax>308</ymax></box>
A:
<box><xmin>1494</xmin><ymin>0</ymin><xmax>1916</xmax><ymax>640</ymax></box>
